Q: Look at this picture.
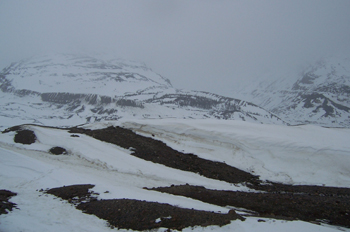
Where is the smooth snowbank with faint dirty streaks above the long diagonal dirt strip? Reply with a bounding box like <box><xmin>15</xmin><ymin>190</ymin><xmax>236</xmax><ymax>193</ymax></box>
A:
<box><xmin>123</xmin><ymin>120</ymin><xmax>350</xmax><ymax>187</ymax></box>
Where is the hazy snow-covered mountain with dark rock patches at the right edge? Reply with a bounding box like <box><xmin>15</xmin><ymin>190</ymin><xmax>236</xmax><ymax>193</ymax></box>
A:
<box><xmin>237</xmin><ymin>57</ymin><xmax>350</xmax><ymax>127</ymax></box>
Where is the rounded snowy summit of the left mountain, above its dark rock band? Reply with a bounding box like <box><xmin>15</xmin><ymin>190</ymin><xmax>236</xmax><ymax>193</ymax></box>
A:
<box><xmin>1</xmin><ymin>54</ymin><xmax>171</xmax><ymax>95</ymax></box>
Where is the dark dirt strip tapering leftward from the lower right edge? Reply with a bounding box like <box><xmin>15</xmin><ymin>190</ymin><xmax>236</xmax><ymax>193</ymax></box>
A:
<box><xmin>150</xmin><ymin>185</ymin><xmax>350</xmax><ymax>227</ymax></box>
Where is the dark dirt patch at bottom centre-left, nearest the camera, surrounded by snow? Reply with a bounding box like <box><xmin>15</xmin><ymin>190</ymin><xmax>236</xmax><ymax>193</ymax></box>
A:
<box><xmin>46</xmin><ymin>185</ymin><xmax>244</xmax><ymax>230</ymax></box>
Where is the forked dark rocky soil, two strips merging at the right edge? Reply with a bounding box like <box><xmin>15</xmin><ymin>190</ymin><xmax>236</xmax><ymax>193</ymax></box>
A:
<box><xmin>70</xmin><ymin>127</ymin><xmax>350</xmax><ymax>227</ymax></box>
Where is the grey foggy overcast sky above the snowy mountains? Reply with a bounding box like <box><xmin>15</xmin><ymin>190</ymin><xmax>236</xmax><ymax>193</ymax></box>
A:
<box><xmin>0</xmin><ymin>0</ymin><xmax>350</xmax><ymax>96</ymax></box>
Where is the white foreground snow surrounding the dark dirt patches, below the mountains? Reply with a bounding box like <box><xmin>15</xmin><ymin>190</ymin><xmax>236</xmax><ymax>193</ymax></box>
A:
<box><xmin>0</xmin><ymin>119</ymin><xmax>350</xmax><ymax>232</ymax></box>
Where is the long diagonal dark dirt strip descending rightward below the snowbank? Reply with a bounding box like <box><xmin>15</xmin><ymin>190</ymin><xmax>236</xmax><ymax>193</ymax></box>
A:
<box><xmin>69</xmin><ymin>127</ymin><xmax>260</xmax><ymax>183</ymax></box>
